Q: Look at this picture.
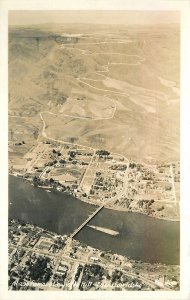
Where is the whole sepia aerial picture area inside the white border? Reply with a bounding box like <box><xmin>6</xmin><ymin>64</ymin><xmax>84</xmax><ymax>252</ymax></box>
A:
<box><xmin>1</xmin><ymin>1</ymin><xmax>190</xmax><ymax>300</ymax></box>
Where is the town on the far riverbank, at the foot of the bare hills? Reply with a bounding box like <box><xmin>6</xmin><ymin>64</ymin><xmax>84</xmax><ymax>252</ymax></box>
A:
<box><xmin>9</xmin><ymin>139</ymin><xmax>180</xmax><ymax>220</ymax></box>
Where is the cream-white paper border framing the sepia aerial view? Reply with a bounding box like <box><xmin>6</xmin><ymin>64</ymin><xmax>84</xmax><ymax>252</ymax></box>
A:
<box><xmin>0</xmin><ymin>0</ymin><xmax>190</xmax><ymax>300</ymax></box>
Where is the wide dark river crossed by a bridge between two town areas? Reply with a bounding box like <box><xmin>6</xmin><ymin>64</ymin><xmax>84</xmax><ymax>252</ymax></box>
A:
<box><xmin>9</xmin><ymin>176</ymin><xmax>180</xmax><ymax>264</ymax></box>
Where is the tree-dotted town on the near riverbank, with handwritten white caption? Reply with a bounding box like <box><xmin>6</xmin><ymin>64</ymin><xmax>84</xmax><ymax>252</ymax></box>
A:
<box><xmin>8</xmin><ymin>219</ymin><xmax>179</xmax><ymax>291</ymax></box>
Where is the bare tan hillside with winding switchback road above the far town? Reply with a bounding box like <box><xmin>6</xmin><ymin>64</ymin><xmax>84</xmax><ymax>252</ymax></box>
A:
<box><xmin>9</xmin><ymin>25</ymin><xmax>180</xmax><ymax>162</ymax></box>
